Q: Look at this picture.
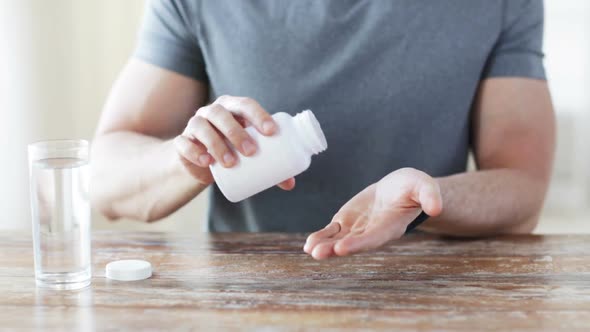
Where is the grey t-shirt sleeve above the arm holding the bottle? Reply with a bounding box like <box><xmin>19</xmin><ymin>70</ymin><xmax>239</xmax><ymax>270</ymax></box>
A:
<box><xmin>133</xmin><ymin>0</ymin><xmax>207</xmax><ymax>81</ymax></box>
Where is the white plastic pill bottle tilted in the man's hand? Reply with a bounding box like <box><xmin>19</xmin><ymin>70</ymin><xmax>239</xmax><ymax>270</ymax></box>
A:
<box><xmin>210</xmin><ymin>110</ymin><xmax>328</xmax><ymax>203</ymax></box>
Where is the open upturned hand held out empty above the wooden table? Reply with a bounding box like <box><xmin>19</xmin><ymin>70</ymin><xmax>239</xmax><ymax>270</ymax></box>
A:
<box><xmin>303</xmin><ymin>168</ymin><xmax>442</xmax><ymax>259</ymax></box>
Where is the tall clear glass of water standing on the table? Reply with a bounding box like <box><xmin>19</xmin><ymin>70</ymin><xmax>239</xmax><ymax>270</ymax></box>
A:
<box><xmin>28</xmin><ymin>140</ymin><xmax>91</xmax><ymax>289</ymax></box>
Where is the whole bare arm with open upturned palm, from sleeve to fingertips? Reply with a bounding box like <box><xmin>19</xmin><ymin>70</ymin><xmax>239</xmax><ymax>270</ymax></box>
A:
<box><xmin>303</xmin><ymin>78</ymin><xmax>555</xmax><ymax>259</ymax></box>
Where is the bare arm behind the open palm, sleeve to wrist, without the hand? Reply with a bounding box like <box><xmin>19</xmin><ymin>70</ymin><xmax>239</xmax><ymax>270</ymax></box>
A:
<box><xmin>419</xmin><ymin>78</ymin><xmax>555</xmax><ymax>236</ymax></box>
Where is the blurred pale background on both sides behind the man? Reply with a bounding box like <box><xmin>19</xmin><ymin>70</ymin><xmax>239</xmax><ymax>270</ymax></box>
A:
<box><xmin>0</xmin><ymin>0</ymin><xmax>590</xmax><ymax>233</ymax></box>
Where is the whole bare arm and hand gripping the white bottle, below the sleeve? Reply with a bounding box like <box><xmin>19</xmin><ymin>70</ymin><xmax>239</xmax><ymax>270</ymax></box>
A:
<box><xmin>91</xmin><ymin>59</ymin><xmax>295</xmax><ymax>221</ymax></box>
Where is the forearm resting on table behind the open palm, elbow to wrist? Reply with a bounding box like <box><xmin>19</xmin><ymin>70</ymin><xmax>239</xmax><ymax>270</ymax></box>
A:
<box><xmin>419</xmin><ymin>169</ymin><xmax>547</xmax><ymax>236</ymax></box>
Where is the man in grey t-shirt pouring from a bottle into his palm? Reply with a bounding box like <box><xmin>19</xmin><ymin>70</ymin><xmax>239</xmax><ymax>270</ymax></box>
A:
<box><xmin>93</xmin><ymin>0</ymin><xmax>554</xmax><ymax>259</ymax></box>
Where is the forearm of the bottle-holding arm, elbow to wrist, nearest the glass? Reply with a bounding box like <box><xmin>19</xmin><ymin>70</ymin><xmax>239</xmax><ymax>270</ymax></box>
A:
<box><xmin>92</xmin><ymin>132</ymin><xmax>206</xmax><ymax>221</ymax></box>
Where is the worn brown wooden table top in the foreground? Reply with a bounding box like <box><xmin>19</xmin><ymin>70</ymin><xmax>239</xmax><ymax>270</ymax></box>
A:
<box><xmin>0</xmin><ymin>232</ymin><xmax>590</xmax><ymax>331</ymax></box>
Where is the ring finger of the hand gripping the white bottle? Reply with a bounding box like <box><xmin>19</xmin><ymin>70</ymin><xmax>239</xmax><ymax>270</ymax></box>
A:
<box><xmin>185</xmin><ymin>116</ymin><xmax>236</xmax><ymax>167</ymax></box>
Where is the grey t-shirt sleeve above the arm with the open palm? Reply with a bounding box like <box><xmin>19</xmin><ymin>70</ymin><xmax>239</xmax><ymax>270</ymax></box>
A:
<box><xmin>482</xmin><ymin>0</ymin><xmax>545</xmax><ymax>80</ymax></box>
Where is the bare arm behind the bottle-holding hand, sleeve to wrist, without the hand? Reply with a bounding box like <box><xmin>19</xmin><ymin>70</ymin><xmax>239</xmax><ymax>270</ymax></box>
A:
<box><xmin>92</xmin><ymin>59</ymin><xmax>210</xmax><ymax>221</ymax></box>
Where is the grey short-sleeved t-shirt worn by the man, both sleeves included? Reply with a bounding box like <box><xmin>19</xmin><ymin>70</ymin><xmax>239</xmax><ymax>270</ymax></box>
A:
<box><xmin>135</xmin><ymin>0</ymin><xmax>545</xmax><ymax>232</ymax></box>
